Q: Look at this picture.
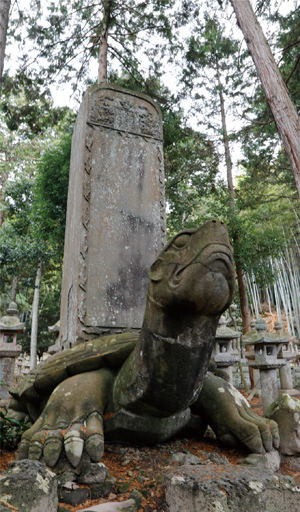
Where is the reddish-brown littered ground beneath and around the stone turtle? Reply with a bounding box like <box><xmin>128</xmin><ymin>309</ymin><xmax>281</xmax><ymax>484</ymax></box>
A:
<box><xmin>0</xmin><ymin>396</ymin><xmax>300</xmax><ymax>512</ymax></box>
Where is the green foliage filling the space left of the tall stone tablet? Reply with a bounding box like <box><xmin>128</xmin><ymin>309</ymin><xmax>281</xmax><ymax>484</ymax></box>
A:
<box><xmin>0</xmin><ymin>78</ymin><xmax>75</xmax><ymax>356</ymax></box>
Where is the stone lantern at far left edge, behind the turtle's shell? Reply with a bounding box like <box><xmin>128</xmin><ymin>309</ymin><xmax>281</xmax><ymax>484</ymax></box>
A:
<box><xmin>0</xmin><ymin>302</ymin><xmax>24</xmax><ymax>403</ymax></box>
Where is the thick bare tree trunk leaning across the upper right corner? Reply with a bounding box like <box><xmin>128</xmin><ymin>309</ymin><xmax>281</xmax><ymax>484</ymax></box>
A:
<box><xmin>230</xmin><ymin>0</ymin><xmax>300</xmax><ymax>196</ymax></box>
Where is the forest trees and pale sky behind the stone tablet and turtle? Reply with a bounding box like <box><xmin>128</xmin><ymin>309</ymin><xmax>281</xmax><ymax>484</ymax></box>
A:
<box><xmin>0</xmin><ymin>0</ymin><xmax>300</xmax><ymax>356</ymax></box>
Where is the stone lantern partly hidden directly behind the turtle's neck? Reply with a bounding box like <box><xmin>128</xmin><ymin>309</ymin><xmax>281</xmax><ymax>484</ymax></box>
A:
<box><xmin>212</xmin><ymin>316</ymin><xmax>241</xmax><ymax>384</ymax></box>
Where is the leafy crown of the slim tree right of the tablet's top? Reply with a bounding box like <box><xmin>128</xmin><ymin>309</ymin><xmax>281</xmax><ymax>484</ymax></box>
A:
<box><xmin>181</xmin><ymin>10</ymin><xmax>248</xmax><ymax>139</ymax></box>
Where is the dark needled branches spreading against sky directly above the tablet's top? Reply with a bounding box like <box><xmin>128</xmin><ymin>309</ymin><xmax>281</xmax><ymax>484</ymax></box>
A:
<box><xmin>8</xmin><ymin>0</ymin><xmax>194</xmax><ymax>94</ymax></box>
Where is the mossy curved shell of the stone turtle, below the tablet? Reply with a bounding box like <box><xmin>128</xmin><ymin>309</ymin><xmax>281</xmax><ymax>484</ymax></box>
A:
<box><xmin>10</xmin><ymin>332</ymin><xmax>138</xmax><ymax>403</ymax></box>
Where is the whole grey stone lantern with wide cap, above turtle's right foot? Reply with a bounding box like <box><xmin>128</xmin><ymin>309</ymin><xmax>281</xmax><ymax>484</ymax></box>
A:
<box><xmin>245</xmin><ymin>319</ymin><xmax>286</xmax><ymax>414</ymax></box>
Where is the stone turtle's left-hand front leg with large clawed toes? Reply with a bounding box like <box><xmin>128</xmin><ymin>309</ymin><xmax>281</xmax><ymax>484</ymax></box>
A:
<box><xmin>20</xmin><ymin>368</ymin><xmax>114</xmax><ymax>468</ymax></box>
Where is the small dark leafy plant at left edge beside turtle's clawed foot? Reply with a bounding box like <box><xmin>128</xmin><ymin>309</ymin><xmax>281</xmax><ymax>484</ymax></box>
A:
<box><xmin>0</xmin><ymin>407</ymin><xmax>30</xmax><ymax>450</ymax></box>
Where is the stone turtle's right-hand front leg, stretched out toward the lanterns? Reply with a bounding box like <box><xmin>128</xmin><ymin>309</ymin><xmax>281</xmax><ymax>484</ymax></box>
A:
<box><xmin>191</xmin><ymin>372</ymin><xmax>279</xmax><ymax>453</ymax></box>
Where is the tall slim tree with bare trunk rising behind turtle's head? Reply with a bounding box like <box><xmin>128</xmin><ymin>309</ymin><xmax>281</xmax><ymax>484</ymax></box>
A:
<box><xmin>184</xmin><ymin>14</ymin><xmax>250</xmax><ymax>332</ymax></box>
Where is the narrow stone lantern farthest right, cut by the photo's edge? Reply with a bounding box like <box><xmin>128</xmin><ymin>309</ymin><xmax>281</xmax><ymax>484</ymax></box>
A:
<box><xmin>274</xmin><ymin>320</ymin><xmax>299</xmax><ymax>396</ymax></box>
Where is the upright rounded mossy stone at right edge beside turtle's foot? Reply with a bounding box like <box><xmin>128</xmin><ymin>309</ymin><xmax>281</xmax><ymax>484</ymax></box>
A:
<box><xmin>266</xmin><ymin>394</ymin><xmax>300</xmax><ymax>455</ymax></box>
